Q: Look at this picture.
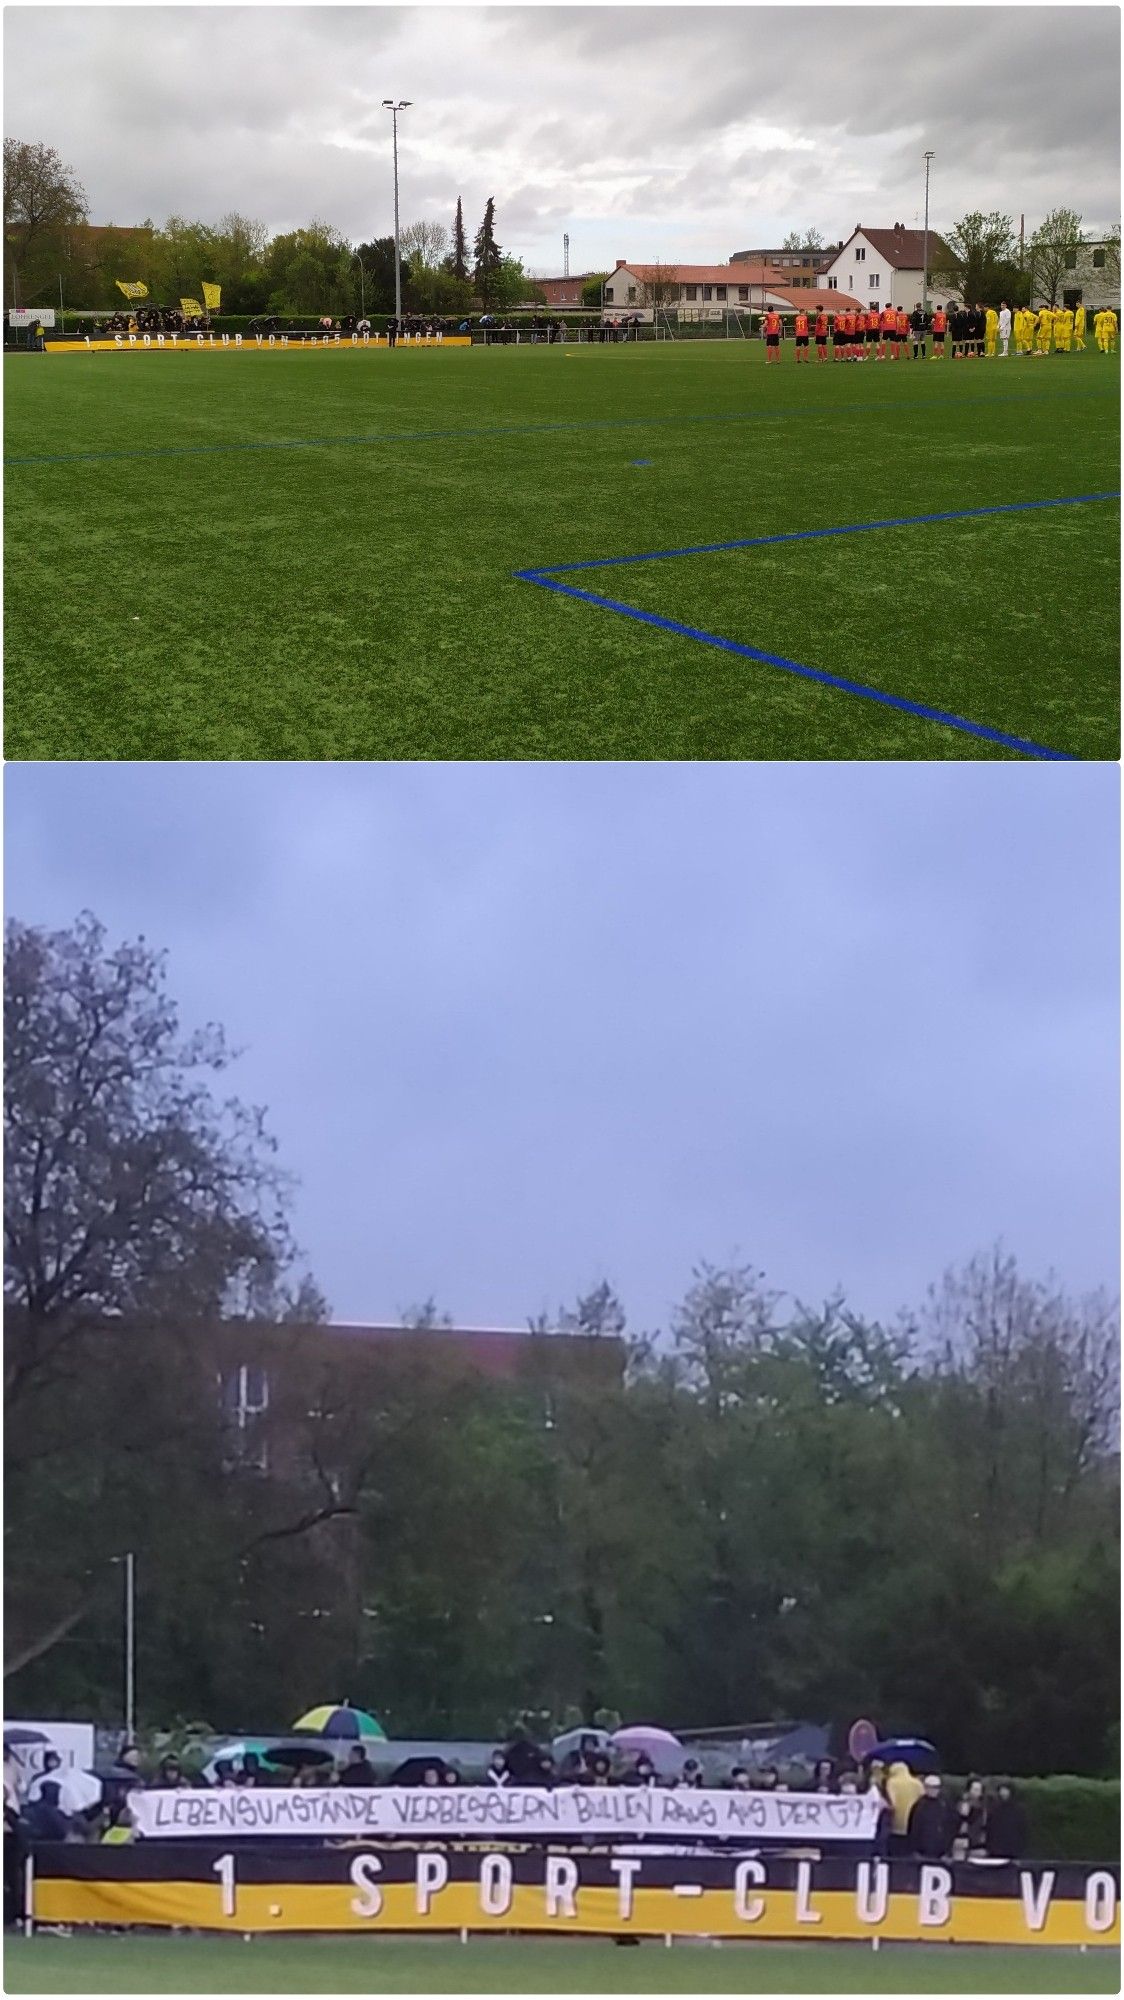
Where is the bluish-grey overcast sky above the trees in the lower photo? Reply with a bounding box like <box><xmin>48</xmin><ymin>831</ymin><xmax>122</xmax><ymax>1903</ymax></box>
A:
<box><xmin>6</xmin><ymin>764</ymin><xmax>1120</xmax><ymax>1326</ymax></box>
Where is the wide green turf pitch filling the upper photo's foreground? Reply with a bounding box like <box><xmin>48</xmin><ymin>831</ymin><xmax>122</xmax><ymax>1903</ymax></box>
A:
<box><xmin>6</xmin><ymin>342</ymin><xmax>1120</xmax><ymax>758</ymax></box>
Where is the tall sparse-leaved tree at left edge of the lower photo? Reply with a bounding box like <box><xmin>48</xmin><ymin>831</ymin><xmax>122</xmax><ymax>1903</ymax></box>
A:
<box><xmin>4</xmin><ymin>914</ymin><xmax>322</xmax><ymax>1696</ymax></box>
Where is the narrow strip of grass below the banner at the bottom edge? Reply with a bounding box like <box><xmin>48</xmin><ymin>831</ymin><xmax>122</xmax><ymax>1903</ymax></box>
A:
<box><xmin>4</xmin><ymin>1936</ymin><xmax>1120</xmax><ymax>1994</ymax></box>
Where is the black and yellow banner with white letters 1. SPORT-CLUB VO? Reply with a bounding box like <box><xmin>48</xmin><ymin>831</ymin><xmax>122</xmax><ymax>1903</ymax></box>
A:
<box><xmin>32</xmin><ymin>1840</ymin><xmax>1120</xmax><ymax>1946</ymax></box>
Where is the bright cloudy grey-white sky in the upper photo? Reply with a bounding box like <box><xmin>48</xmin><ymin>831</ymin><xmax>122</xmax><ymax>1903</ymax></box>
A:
<box><xmin>4</xmin><ymin>4</ymin><xmax>1120</xmax><ymax>276</ymax></box>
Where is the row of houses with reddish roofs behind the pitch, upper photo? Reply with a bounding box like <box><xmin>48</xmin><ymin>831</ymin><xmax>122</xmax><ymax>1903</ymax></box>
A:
<box><xmin>538</xmin><ymin>222</ymin><xmax>1120</xmax><ymax>318</ymax></box>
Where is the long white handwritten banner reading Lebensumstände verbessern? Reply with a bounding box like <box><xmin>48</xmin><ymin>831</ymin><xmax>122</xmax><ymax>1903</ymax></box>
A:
<box><xmin>130</xmin><ymin>1784</ymin><xmax>880</xmax><ymax>1842</ymax></box>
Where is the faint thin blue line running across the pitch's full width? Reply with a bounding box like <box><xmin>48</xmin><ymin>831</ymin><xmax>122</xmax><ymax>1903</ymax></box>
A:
<box><xmin>4</xmin><ymin>388</ymin><xmax>1116</xmax><ymax>466</ymax></box>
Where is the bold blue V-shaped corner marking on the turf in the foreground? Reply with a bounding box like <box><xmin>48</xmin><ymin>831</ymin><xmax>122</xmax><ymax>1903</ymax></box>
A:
<box><xmin>514</xmin><ymin>492</ymin><xmax>1120</xmax><ymax>764</ymax></box>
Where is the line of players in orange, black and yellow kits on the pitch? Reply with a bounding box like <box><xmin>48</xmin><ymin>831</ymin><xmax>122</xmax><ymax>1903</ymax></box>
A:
<box><xmin>762</xmin><ymin>304</ymin><xmax>1118</xmax><ymax>362</ymax></box>
